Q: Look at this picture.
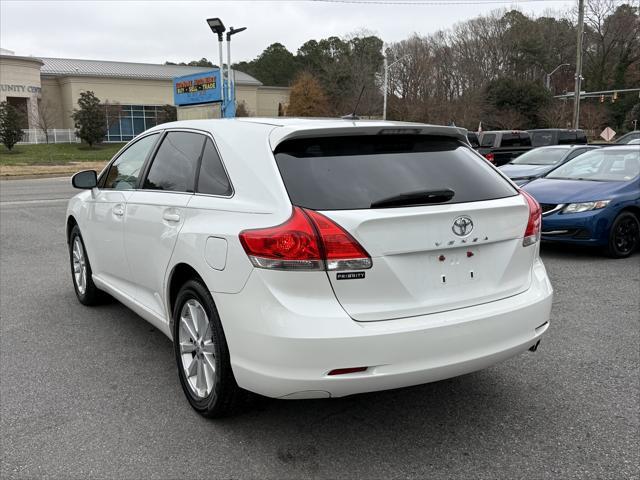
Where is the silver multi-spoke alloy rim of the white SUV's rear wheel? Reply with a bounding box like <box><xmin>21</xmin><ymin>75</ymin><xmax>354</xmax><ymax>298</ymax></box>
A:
<box><xmin>178</xmin><ymin>298</ymin><xmax>216</xmax><ymax>399</ymax></box>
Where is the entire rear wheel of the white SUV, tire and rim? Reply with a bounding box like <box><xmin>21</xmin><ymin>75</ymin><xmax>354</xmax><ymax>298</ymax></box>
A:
<box><xmin>173</xmin><ymin>280</ymin><xmax>245</xmax><ymax>417</ymax></box>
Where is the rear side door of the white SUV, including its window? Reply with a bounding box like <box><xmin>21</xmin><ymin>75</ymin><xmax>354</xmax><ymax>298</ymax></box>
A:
<box><xmin>124</xmin><ymin>130</ymin><xmax>206</xmax><ymax>317</ymax></box>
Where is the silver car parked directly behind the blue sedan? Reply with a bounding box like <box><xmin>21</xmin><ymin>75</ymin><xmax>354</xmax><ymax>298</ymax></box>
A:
<box><xmin>500</xmin><ymin>145</ymin><xmax>599</xmax><ymax>186</ymax></box>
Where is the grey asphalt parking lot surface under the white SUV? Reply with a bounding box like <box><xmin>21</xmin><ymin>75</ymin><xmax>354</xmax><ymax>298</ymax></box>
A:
<box><xmin>0</xmin><ymin>179</ymin><xmax>640</xmax><ymax>479</ymax></box>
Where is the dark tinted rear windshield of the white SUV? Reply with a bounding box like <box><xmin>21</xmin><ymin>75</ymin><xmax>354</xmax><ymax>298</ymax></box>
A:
<box><xmin>274</xmin><ymin>135</ymin><xmax>516</xmax><ymax>210</ymax></box>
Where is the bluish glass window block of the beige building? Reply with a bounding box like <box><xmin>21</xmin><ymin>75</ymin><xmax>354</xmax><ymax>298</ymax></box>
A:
<box><xmin>104</xmin><ymin>104</ymin><xmax>164</xmax><ymax>142</ymax></box>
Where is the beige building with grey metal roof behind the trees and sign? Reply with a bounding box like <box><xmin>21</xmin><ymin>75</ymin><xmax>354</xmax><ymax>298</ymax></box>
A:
<box><xmin>0</xmin><ymin>50</ymin><xmax>289</xmax><ymax>141</ymax></box>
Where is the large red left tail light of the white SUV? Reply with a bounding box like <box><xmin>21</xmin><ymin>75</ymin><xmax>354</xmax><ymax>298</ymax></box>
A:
<box><xmin>240</xmin><ymin>207</ymin><xmax>372</xmax><ymax>270</ymax></box>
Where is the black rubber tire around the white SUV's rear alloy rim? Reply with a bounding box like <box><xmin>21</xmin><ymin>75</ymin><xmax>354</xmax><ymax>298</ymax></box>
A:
<box><xmin>173</xmin><ymin>280</ymin><xmax>247</xmax><ymax>418</ymax></box>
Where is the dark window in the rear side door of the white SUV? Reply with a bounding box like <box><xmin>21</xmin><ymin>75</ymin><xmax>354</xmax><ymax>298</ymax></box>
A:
<box><xmin>143</xmin><ymin>132</ymin><xmax>206</xmax><ymax>192</ymax></box>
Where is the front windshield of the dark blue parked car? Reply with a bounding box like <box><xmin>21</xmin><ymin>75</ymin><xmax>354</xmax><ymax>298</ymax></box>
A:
<box><xmin>546</xmin><ymin>148</ymin><xmax>640</xmax><ymax>182</ymax></box>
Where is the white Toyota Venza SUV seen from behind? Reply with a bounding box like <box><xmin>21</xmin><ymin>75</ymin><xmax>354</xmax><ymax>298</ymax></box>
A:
<box><xmin>66</xmin><ymin>118</ymin><xmax>552</xmax><ymax>417</ymax></box>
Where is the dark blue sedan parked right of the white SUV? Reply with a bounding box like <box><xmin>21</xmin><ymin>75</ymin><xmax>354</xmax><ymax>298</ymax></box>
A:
<box><xmin>524</xmin><ymin>146</ymin><xmax>640</xmax><ymax>258</ymax></box>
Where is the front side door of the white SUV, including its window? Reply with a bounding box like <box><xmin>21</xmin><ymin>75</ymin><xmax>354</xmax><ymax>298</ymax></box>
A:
<box><xmin>82</xmin><ymin>133</ymin><xmax>160</xmax><ymax>292</ymax></box>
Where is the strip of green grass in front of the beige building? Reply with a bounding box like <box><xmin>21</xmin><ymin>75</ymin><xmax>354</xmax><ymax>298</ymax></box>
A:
<box><xmin>0</xmin><ymin>143</ymin><xmax>124</xmax><ymax>166</ymax></box>
